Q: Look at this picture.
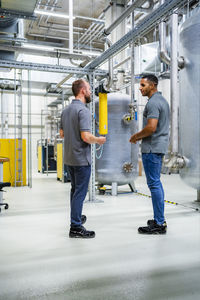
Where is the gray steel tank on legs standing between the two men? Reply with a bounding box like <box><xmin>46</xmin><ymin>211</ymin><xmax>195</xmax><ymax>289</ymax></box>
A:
<box><xmin>95</xmin><ymin>93</ymin><xmax>138</xmax><ymax>185</ymax></box>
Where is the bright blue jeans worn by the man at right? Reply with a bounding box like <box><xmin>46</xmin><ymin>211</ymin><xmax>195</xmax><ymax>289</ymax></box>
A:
<box><xmin>142</xmin><ymin>153</ymin><xmax>165</xmax><ymax>225</ymax></box>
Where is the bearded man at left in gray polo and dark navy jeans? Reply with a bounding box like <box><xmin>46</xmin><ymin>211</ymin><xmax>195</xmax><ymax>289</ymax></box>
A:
<box><xmin>60</xmin><ymin>79</ymin><xmax>106</xmax><ymax>238</ymax></box>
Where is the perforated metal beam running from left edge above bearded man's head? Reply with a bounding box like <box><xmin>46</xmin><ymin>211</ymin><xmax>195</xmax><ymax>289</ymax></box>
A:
<box><xmin>0</xmin><ymin>60</ymin><xmax>107</xmax><ymax>76</ymax></box>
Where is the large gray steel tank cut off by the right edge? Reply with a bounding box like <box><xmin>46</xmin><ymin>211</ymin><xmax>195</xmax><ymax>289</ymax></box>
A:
<box><xmin>179</xmin><ymin>10</ymin><xmax>200</xmax><ymax>190</ymax></box>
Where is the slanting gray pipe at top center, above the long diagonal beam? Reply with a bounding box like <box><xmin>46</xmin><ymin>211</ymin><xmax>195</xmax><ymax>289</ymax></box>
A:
<box><xmin>104</xmin><ymin>0</ymin><xmax>147</xmax><ymax>35</ymax></box>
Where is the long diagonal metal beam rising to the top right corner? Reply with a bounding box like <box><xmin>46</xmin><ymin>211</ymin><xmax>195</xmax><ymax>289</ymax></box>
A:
<box><xmin>85</xmin><ymin>0</ymin><xmax>188</xmax><ymax>69</ymax></box>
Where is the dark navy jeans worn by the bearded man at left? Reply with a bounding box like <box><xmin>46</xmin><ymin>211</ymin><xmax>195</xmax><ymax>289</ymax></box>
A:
<box><xmin>68</xmin><ymin>165</ymin><xmax>91</xmax><ymax>227</ymax></box>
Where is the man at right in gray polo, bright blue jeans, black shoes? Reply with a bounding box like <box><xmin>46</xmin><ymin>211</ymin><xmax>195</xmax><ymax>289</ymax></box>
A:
<box><xmin>130</xmin><ymin>74</ymin><xmax>170</xmax><ymax>234</ymax></box>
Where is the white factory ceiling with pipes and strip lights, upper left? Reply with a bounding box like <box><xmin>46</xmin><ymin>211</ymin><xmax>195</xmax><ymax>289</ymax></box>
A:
<box><xmin>0</xmin><ymin>0</ymin><xmax>109</xmax><ymax>58</ymax></box>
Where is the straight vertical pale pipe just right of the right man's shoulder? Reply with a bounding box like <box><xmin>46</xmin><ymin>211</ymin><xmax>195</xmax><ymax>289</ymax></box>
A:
<box><xmin>170</xmin><ymin>14</ymin><xmax>179</xmax><ymax>153</ymax></box>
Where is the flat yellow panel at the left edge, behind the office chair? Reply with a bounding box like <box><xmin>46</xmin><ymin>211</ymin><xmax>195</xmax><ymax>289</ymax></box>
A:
<box><xmin>0</xmin><ymin>139</ymin><xmax>26</xmax><ymax>186</ymax></box>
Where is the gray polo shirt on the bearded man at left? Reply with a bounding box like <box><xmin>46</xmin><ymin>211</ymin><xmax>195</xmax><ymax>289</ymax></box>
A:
<box><xmin>60</xmin><ymin>99</ymin><xmax>91</xmax><ymax>166</ymax></box>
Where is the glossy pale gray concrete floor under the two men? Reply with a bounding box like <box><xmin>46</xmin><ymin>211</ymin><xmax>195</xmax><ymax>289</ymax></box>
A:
<box><xmin>0</xmin><ymin>174</ymin><xmax>200</xmax><ymax>300</ymax></box>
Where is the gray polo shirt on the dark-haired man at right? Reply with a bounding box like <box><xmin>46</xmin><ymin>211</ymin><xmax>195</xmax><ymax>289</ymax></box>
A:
<box><xmin>141</xmin><ymin>92</ymin><xmax>170</xmax><ymax>154</ymax></box>
